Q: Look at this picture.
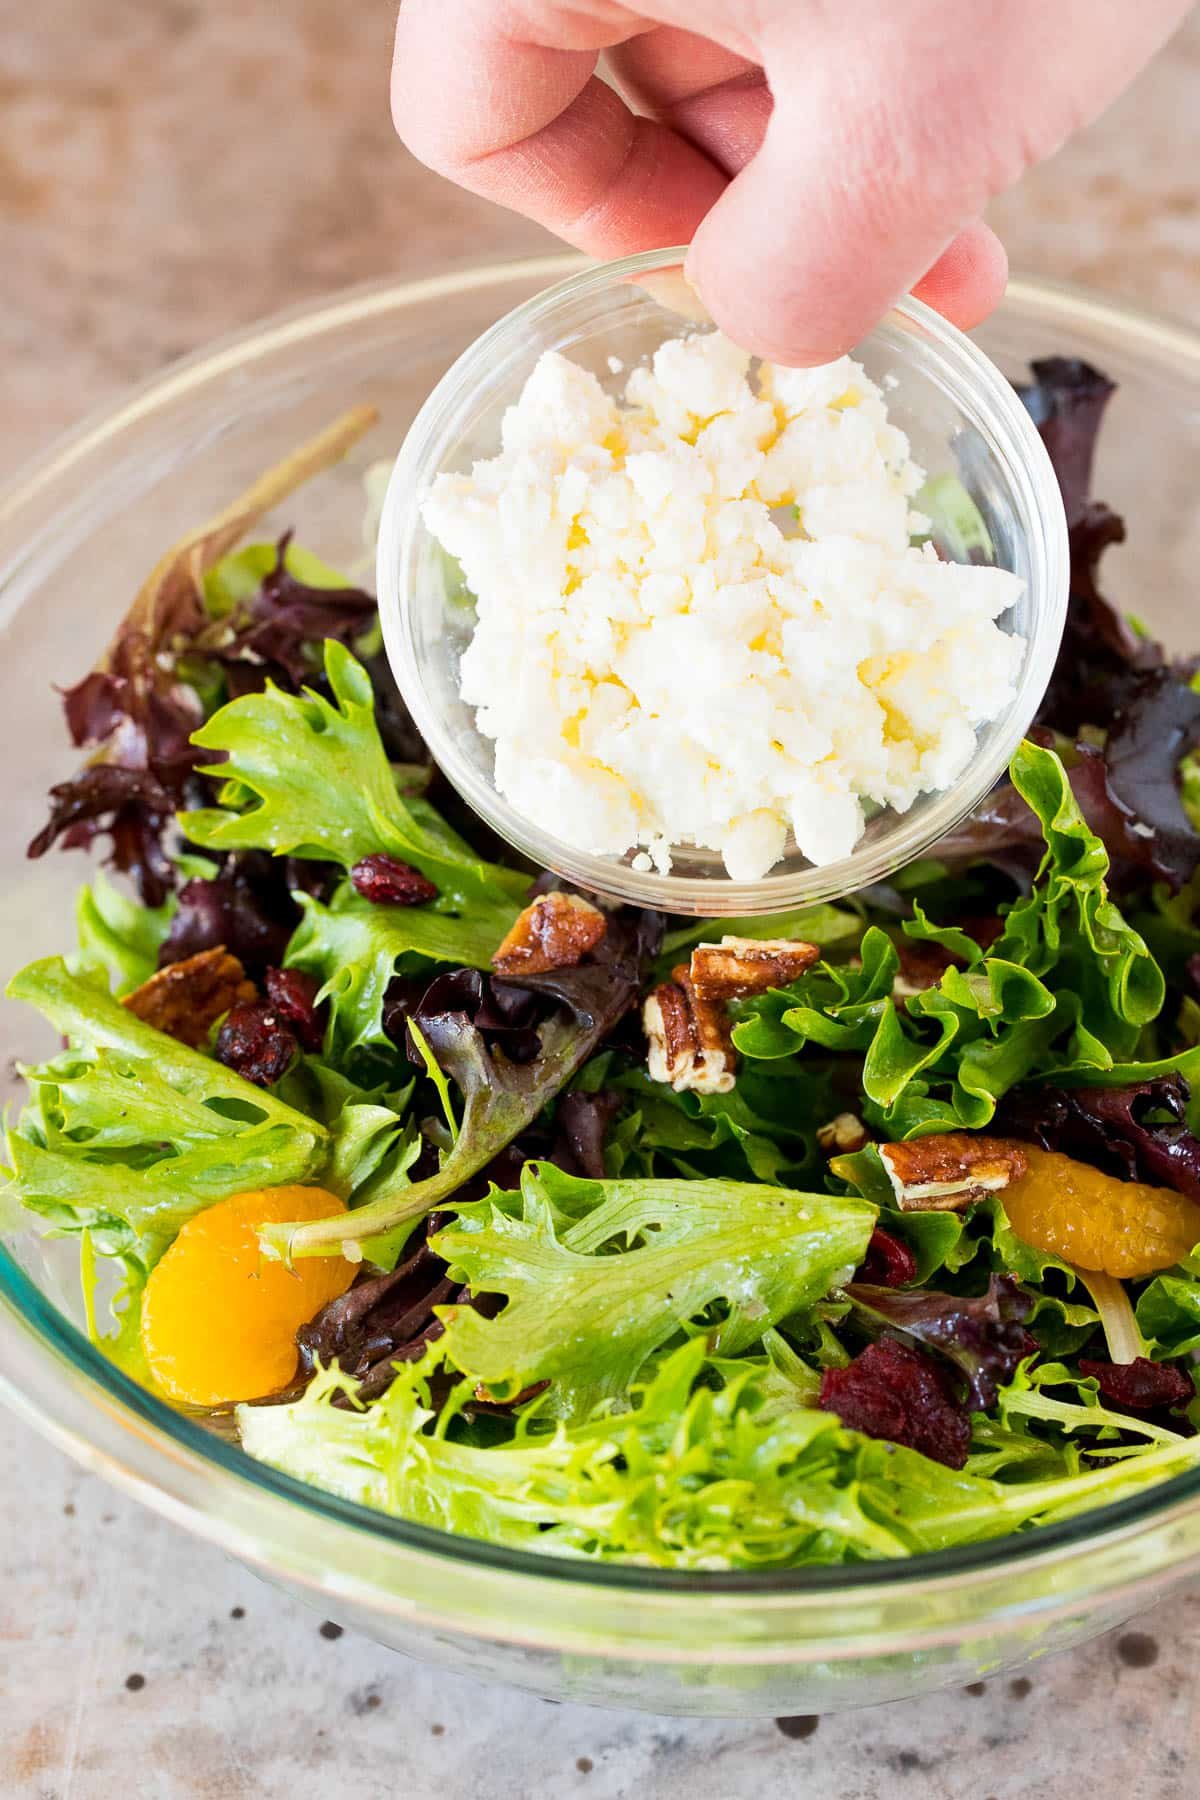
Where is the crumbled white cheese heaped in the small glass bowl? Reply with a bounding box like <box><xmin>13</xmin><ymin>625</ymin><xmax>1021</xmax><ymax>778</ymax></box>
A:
<box><xmin>423</xmin><ymin>331</ymin><xmax>1024</xmax><ymax>882</ymax></box>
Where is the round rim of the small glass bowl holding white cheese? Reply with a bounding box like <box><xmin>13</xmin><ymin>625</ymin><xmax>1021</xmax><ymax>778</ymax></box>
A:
<box><xmin>376</xmin><ymin>245</ymin><xmax>1069</xmax><ymax>918</ymax></box>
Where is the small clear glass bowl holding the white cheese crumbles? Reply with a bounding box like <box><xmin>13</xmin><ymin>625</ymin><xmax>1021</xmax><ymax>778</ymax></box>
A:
<box><xmin>378</xmin><ymin>250</ymin><xmax>1069</xmax><ymax>916</ymax></box>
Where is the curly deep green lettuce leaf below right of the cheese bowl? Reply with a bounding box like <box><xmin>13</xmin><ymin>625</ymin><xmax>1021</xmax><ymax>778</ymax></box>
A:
<box><xmin>734</xmin><ymin>743</ymin><xmax>1164</xmax><ymax>1138</ymax></box>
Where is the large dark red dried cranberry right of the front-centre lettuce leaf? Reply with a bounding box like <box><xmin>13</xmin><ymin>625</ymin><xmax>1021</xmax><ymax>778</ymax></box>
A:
<box><xmin>819</xmin><ymin>1337</ymin><xmax>972</xmax><ymax>1469</ymax></box>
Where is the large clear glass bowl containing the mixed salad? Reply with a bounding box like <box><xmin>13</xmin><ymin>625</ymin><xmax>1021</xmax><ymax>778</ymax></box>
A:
<box><xmin>0</xmin><ymin>257</ymin><xmax>1200</xmax><ymax>1715</ymax></box>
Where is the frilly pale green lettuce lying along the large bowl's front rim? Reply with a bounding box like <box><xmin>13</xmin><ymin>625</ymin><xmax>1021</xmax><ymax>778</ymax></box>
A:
<box><xmin>237</xmin><ymin>1339</ymin><xmax>1200</xmax><ymax>1570</ymax></box>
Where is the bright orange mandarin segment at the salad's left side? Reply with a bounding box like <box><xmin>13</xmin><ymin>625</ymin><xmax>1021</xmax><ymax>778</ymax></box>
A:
<box><xmin>142</xmin><ymin>1188</ymin><xmax>358</xmax><ymax>1406</ymax></box>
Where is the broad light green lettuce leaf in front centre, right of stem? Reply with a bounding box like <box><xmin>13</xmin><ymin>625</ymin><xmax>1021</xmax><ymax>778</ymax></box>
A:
<box><xmin>430</xmin><ymin>1163</ymin><xmax>876</xmax><ymax>1415</ymax></box>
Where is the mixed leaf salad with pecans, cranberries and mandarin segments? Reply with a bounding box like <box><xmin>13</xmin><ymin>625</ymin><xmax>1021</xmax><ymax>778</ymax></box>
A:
<box><xmin>7</xmin><ymin>358</ymin><xmax>1200</xmax><ymax>1570</ymax></box>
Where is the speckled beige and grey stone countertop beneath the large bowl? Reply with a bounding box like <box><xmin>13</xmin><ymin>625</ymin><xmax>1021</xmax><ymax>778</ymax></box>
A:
<box><xmin>0</xmin><ymin>0</ymin><xmax>1200</xmax><ymax>1800</ymax></box>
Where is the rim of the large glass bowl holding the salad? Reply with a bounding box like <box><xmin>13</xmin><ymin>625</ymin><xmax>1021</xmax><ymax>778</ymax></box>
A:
<box><xmin>0</xmin><ymin>252</ymin><xmax>1200</xmax><ymax>1606</ymax></box>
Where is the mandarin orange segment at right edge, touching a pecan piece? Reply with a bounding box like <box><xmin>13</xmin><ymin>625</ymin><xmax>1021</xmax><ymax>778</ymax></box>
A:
<box><xmin>1002</xmin><ymin>1148</ymin><xmax>1200</xmax><ymax>1282</ymax></box>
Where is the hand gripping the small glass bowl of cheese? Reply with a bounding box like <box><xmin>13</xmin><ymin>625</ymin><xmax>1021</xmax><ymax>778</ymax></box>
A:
<box><xmin>392</xmin><ymin>0</ymin><xmax>1189</xmax><ymax>364</ymax></box>
